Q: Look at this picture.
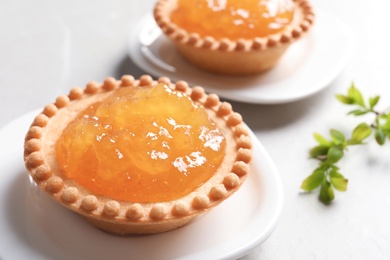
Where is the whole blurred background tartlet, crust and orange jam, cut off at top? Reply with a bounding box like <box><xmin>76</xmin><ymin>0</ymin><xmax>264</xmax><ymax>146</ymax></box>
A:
<box><xmin>154</xmin><ymin>0</ymin><xmax>314</xmax><ymax>75</ymax></box>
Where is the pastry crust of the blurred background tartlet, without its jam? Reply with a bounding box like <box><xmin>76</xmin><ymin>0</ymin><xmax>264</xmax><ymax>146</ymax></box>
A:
<box><xmin>154</xmin><ymin>0</ymin><xmax>315</xmax><ymax>75</ymax></box>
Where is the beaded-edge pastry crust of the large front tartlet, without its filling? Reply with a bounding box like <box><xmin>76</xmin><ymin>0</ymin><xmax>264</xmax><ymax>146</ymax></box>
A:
<box><xmin>24</xmin><ymin>75</ymin><xmax>252</xmax><ymax>234</ymax></box>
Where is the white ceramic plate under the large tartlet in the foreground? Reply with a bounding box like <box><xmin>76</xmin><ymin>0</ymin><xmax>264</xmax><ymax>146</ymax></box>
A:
<box><xmin>0</xmin><ymin>111</ymin><xmax>283</xmax><ymax>260</ymax></box>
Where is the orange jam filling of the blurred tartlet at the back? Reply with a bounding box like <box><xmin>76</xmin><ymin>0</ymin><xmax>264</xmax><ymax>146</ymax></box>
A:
<box><xmin>171</xmin><ymin>0</ymin><xmax>294</xmax><ymax>40</ymax></box>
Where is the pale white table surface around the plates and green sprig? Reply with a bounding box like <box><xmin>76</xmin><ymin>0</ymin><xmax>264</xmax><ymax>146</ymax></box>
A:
<box><xmin>0</xmin><ymin>0</ymin><xmax>390</xmax><ymax>260</ymax></box>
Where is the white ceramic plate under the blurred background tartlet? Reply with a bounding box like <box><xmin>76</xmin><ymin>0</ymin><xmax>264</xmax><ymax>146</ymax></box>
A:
<box><xmin>129</xmin><ymin>11</ymin><xmax>355</xmax><ymax>104</ymax></box>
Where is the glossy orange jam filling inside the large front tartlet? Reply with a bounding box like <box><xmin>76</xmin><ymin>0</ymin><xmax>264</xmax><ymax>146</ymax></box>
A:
<box><xmin>56</xmin><ymin>84</ymin><xmax>226</xmax><ymax>202</ymax></box>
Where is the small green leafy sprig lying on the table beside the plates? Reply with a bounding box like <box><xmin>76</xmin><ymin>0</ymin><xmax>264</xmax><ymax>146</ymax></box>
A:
<box><xmin>301</xmin><ymin>83</ymin><xmax>390</xmax><ymax>204</ymax></box>
